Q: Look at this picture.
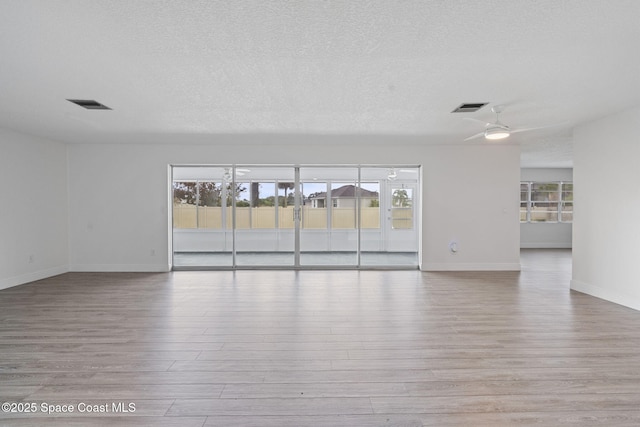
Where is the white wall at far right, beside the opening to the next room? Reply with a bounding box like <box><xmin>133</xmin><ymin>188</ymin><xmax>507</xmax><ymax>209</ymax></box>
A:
<box><xmin>571</xmin><ymin>108</ymin><xmax>640</xmax><ymax>309</ymax></box>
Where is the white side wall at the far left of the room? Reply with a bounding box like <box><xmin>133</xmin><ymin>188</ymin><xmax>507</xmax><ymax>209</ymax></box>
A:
<box><xmin>0</xmin><ymin>129</ymin><xmax>68</xmax><ymax>289</ymax></box>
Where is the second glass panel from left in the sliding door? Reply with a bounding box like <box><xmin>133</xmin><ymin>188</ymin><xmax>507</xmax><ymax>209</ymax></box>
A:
<box><xmin>235</xmin><ymin>166</ymin><xmax>295</xmax><ymax>267</ymax></box>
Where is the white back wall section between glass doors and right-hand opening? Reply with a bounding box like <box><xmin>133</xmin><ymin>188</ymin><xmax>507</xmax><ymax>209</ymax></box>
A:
<box><xmin>419</xmin><ymin>143</ymin><xmax>520</xmax><ymax>270</ymax></box>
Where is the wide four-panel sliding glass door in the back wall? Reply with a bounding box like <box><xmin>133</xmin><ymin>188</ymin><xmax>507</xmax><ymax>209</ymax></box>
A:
<box><xmin>172</xmin><ymin>165</ymin><xmax>419</xmax><ymax>269</ymax></box>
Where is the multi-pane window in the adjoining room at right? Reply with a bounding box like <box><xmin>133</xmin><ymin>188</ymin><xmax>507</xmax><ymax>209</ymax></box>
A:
<box><xmin>520</xmin><ymin>182</ymin><xmax>573</xmax><ymax>222</ymax></box>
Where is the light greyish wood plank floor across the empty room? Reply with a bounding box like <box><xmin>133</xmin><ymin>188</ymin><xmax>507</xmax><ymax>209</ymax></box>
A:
<box><xmin>0</xmin><ymin>250</ymin><xmax>640</xmax><ymax>427</ymax></box>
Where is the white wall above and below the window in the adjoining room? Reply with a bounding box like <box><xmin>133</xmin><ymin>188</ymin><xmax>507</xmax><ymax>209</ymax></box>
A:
<box><xmin>520</xmin><ymin>168</ymin><xmax>573</xmax><ymax>248</ymax></box>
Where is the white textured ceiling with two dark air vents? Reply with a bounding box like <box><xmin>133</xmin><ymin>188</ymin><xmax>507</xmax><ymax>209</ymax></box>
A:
<box><xmin>0</xmin><ymin>0</ymin><xmax>640</xmax><ymax>167</ymax></box>
